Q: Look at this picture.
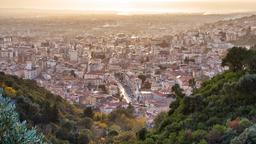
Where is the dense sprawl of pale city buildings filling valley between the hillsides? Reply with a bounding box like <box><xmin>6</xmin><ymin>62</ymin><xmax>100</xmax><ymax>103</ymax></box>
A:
<box><xmin>0</xmin><ymin>12</ymin><xmax>256</xmax><ymax>126</ymax></box>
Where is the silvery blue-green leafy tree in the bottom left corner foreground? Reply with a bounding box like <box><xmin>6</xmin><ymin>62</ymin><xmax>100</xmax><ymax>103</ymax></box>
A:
<box><xmin>0</xmin><ymin>97</ymin><xmax>46</xmax><ymax>144</ymax></box>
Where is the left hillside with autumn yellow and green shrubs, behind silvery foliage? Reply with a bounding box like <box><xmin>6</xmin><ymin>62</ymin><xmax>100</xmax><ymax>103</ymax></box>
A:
<box><xmin>0</xmin><ymin>72</ymin><xmax>145</xmax><ymax>144</ymax></box>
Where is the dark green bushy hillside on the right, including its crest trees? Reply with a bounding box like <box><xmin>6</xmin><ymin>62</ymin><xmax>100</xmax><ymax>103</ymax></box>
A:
<box><xmin>138</xmin><ymin>47</ymin><xmax>256</xmax><ymax>144</ymax></box>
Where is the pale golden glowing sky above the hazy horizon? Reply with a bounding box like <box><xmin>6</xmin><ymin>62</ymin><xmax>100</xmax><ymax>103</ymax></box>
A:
<box><xmin>0</xmin><ymin>0</ymin><xmax>256</xmax><ymax>13</ymax></box>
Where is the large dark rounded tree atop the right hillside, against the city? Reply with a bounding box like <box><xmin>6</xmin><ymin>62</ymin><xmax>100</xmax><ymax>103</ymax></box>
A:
<box><xmin>222</xmin><ymin>47</ymin><xmax>250</xmax><ymax>72</ymax></box>
